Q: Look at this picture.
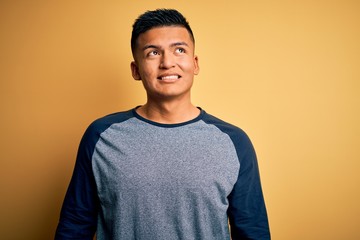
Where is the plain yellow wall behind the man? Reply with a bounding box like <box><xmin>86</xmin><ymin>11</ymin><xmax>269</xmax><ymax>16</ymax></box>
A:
<box><xmin>0</xmin><ymin>0</ymin><xmax>360</xmax><ymax>240</ymax></box>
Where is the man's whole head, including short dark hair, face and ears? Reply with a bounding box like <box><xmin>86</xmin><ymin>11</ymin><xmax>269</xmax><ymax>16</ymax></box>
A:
<box><xmin>130</xmin><ymin>9</ymin><xmax>199</xmax><ymax>101</ymax></box>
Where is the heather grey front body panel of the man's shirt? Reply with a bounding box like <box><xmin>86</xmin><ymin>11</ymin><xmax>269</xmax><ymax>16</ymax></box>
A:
<box><xmin>91</xmin><ymin>117</ymin><xmax>240</xmax><ymax>240</ymax></box>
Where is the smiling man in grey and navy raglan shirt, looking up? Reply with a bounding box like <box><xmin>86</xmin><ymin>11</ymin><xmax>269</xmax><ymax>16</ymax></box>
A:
<box><xmin>56</xmin><ymin>9</ymin><xmax>270</xmax><ymax>240</ymax></box>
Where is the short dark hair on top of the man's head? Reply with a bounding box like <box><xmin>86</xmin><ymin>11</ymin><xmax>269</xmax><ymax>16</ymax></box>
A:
<box><xmin>131</xmin><ymin>9</ymin><xmax>195</xmax><ymax>54</ymax></box>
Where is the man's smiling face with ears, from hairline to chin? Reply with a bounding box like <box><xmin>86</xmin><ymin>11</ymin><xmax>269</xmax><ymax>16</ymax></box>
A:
<box><xmin>131</xmin><ymin>26</ymin><xmax>199</xmax><ymax>100</ymax></box>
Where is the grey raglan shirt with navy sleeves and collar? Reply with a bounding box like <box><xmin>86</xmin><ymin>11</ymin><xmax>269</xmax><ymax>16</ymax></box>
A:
<box><xmin>56</xmin><ymin>109</ymin><xmax>270</xmax><ymax>240</ymax></box>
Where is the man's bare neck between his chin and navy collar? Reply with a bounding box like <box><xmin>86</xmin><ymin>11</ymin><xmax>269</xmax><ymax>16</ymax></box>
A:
<box><xmin>136</xmin><ymin>97</ymin><xmax>200</xmax><ymax>124</ymax></box>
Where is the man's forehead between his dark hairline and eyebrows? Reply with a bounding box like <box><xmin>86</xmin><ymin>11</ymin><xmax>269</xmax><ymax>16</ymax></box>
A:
<box><xmin>137</xmin><ymin>26</ymin><xmax>194</xmax><ymax>49</ymax></box>
